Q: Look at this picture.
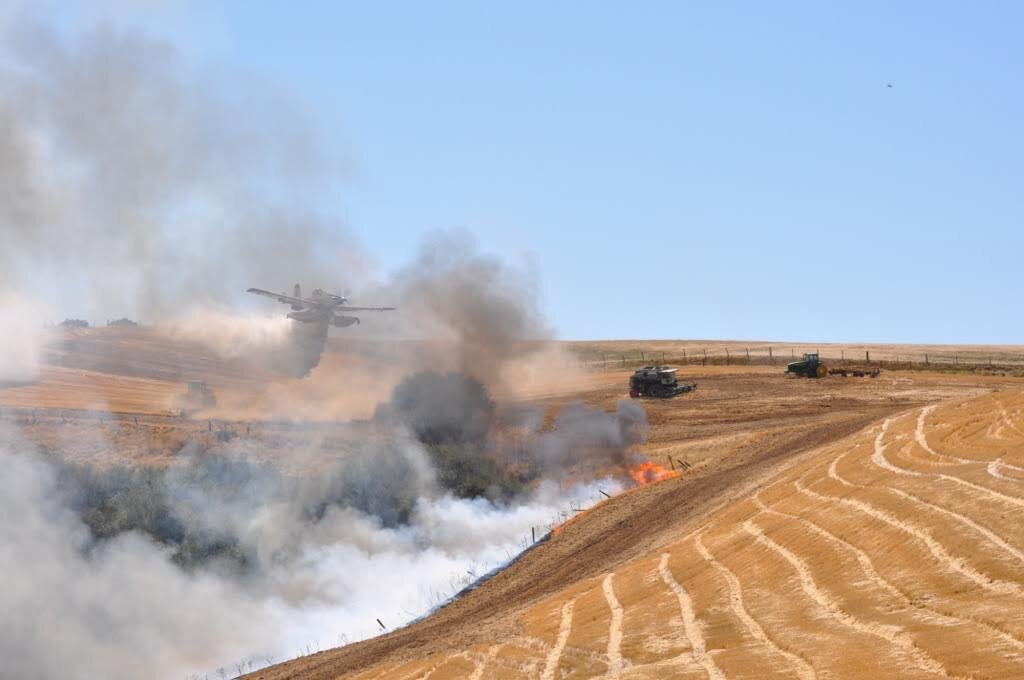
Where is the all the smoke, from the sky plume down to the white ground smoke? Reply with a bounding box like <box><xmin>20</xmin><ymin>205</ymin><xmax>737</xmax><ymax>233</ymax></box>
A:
<box><xmin>0</xmin><ymin>15</ymin><xmax>640</xmax><ymax>680</ymax></box>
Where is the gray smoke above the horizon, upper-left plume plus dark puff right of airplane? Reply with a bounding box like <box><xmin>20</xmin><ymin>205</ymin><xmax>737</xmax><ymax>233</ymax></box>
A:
<box><xmin>0</xmin><ymin>18</ymin><xmax>550</xmax><ymax>383</ymax></box>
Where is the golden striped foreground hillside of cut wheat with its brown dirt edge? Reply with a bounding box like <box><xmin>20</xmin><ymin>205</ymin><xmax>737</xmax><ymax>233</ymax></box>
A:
<box><xmin>253</xmin><ymin>389</ymin><xmax>1024</xmax><ymax>680</ymax></box>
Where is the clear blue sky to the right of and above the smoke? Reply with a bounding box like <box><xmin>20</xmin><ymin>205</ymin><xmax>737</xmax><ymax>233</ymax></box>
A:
<box><xmin>41</xmin><ymin>2</ymin><xmax>1024</xmax><ymax>343</ymax></box>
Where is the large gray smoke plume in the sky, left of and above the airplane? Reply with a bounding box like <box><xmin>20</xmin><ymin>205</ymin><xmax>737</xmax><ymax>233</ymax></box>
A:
<box><xmin>0</xmin><ymin>17</ymin><xmax>366</xmax><ymax>321</ymax></box>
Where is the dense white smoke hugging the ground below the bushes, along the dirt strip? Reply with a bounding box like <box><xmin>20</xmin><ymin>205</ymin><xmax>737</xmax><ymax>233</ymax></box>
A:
<box><xmin>0</xmin><ymin>431</ymin><xmax>617</xmax><ymax>680</ymax></box>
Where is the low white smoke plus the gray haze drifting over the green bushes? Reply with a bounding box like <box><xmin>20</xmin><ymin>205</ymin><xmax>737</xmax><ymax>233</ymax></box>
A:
<box><xmin>0</xmin><ymin>421</ymin><xmax>617</xmax><ymax>680</ymax></box>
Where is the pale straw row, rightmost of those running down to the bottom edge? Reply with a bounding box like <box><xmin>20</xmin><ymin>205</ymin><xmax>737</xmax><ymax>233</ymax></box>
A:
<box><xmin>743</xmin><ymin>519</ymin><xmax>958</xmax><ymax>678</ymax></box>
